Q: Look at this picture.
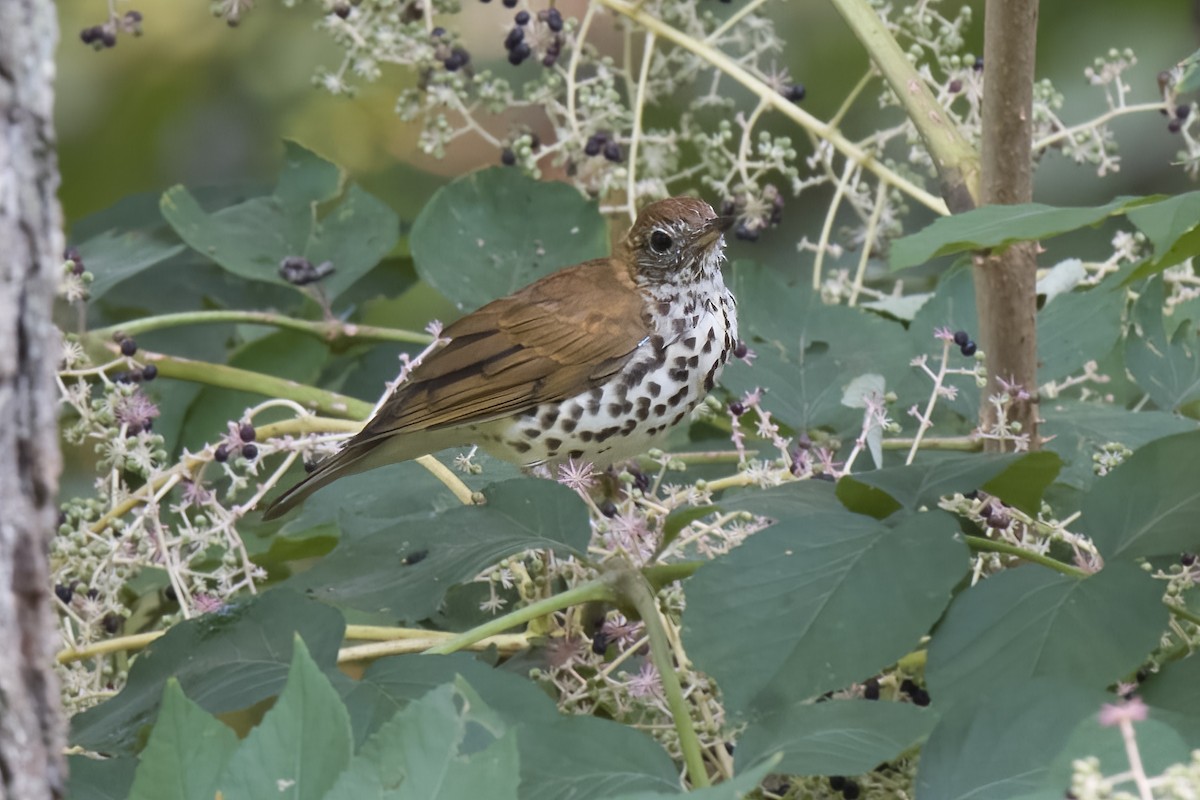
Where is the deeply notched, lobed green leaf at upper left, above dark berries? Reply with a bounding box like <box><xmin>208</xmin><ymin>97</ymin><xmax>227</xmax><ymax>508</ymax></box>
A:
<box><xmin>160</xmin><ymin>142</ymin><xmax>400</xmax><ymax>297</ymax></box>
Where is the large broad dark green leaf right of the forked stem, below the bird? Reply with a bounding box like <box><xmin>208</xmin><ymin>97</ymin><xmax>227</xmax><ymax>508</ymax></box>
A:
<box><xmin>683</xmin><ymin>501</ymin><xmax>968</xmax><ymax>715</ymax></box>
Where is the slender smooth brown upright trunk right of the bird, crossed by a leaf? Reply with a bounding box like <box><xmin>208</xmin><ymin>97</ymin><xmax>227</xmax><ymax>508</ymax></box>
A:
<box><xmin>974</xmin><ymin>0</ymin><xmax>1039</xmax><ymax>449</ymax></box>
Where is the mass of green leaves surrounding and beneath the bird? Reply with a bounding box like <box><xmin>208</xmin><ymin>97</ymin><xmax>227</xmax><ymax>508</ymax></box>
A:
<box><xmin>54</xmin><ymin>153</ymin><xmax>1200</xmax><ymax>800</ymax></box>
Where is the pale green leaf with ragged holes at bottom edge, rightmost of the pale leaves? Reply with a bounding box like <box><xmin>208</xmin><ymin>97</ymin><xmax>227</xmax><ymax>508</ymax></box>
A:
<box><xmin>325</xmin><ymin>684</ymin><xmax>518</xmax><ymax>800</ymax></box>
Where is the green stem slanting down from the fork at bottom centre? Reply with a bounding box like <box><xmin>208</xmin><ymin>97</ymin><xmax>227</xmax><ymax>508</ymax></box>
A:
<box><xmin>608</xmin><ymin>569</ymin><xmax>709</xmax><ymax>788</ymax></box>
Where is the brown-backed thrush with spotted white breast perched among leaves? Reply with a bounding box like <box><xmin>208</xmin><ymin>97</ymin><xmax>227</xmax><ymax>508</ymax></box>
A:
<box><xmin>264</xmin><ymin>197</ymin><xmax>738</xmax><ymax>519</ymax></box>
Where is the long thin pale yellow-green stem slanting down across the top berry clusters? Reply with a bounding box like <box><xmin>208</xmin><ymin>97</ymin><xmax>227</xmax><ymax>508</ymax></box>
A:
<box><xmin>597</xmin><ymin>0</ymin><xmax>947</xmax><ymax>213</ymax></box>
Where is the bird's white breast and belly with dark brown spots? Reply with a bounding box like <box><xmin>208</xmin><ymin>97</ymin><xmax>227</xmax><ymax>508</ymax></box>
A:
<box><xmin>479</xmin><ymin>279</ymin><xmax>738</xmax><ymax>467</ymax></box>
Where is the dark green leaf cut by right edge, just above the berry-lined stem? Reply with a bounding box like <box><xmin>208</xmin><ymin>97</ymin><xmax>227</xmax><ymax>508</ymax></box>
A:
<box><xmin>1078</xmin><ymin>431</ymin><xmax>1200</xmax><ymax>560</ymax></box>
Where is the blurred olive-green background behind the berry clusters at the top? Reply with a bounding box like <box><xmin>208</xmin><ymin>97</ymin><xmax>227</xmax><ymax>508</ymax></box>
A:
<box><xmin>58</xmin><ymin>0</ymin><xmax>1200</xmax><ymax>242</ymax></box>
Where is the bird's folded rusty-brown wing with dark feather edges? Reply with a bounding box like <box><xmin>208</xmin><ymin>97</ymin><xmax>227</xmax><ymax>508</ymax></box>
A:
<box><xmin>355</xmin><ymin>259</ymin><xmax>648</xmax><ymax>443</ymax></box>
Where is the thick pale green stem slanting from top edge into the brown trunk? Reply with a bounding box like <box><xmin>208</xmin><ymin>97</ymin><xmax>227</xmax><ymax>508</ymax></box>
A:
<box><xmin>829</xmin><ymin>0</ymin><xmax>991</xmax><ymax>213</ymax></box>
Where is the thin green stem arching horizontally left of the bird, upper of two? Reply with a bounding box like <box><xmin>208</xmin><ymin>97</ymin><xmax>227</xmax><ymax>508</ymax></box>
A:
<box><xmin>91</xmin><ymin>311</ymin><xmax>433</xmax><ymax>344</ymax></box>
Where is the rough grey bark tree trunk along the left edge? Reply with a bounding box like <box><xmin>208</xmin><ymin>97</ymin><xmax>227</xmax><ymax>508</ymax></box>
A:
<box><xmin>0</xmin><ymin>0</ymin><xmax>66</xmax><ymax>800</ymax></box>
